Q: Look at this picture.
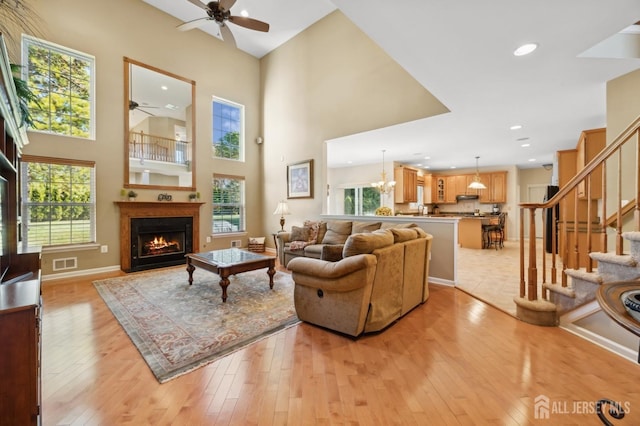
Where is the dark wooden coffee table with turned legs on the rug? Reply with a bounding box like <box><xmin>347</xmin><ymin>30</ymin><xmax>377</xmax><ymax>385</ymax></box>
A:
<box><xmin>185</xmin><ymin>248</ymin><xmax>276</xmax><ymax>302</ymax></box>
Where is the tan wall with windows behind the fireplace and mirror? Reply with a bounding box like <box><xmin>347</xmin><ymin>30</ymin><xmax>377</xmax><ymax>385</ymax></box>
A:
<box><xmin>16</xmin><ymin>0</ymin><xmax>262</xmax><ymax>274</ymax></box>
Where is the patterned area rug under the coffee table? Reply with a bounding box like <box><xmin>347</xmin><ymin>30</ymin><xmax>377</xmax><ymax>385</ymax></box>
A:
<box><xmin>93</xmin><ymin>267</ymin><xmax>299</xmax><ymax>383</ymax></box>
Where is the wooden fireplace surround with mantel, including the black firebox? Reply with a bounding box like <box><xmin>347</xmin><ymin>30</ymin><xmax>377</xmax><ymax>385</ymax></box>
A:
<box><xmin>115</xmin><ymin>201</ymin><xmax>204</xmax><ymax>272</ymax></box>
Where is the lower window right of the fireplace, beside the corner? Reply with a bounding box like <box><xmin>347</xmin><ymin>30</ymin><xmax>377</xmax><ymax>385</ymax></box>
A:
<box><xmin>213</xmin><ymin>175</ymin><xmax>245</xmax><ymax>234</ymax></box>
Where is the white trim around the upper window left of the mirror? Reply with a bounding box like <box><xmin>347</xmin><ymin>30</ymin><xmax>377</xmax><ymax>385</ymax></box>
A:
<box><xmin>21</xmin><ymin>34</ymin><xmax>97</xmax><ymax>141</ymax></box>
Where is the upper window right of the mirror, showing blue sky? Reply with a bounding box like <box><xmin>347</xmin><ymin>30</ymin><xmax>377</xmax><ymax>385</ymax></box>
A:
<box><xmin>213</xmin><ymin>98</ymin><xmax>244</xmax><ymax>160</ymax></box>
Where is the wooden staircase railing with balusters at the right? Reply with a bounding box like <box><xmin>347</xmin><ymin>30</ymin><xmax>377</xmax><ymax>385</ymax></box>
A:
<box><xmin>520</xmin><ymin>117</ymin><xmax>640</xmax><ymax>302</ymax></box>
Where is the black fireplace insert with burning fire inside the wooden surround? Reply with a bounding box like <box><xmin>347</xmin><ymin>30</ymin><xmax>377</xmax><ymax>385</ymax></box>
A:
<box><xmin>130</xmin><ymin>217</ymin><xmax>193</xmax><ymax>271</ymax></box>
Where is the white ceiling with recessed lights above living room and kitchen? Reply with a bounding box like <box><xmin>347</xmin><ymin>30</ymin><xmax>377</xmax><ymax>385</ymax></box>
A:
<box><xmin>144</xmin><ymin>0</ymin><xmax>640</xmax><ymax>170</ymax></box>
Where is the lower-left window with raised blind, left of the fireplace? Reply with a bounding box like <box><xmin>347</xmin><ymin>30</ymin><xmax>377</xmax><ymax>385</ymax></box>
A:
<box><xmin>20</xmin><ymin>155</ymin><xmax>96</xmax><ymax>246</ymax></box>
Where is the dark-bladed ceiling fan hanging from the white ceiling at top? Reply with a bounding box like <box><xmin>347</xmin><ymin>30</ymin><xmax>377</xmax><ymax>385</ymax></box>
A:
<box><xmin>177</xmin><ymin>0</ymin><xmax>269</xmax><ymax>46</ymax></box>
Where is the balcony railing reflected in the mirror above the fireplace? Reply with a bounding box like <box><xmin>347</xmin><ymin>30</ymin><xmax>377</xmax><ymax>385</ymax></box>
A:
<box><xmin>129</xmin><ymin>132</ymin><xmax>192</xmax><ymax>166</ymax></box>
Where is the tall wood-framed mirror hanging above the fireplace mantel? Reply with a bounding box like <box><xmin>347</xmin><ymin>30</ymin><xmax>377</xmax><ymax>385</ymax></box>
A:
<box><xmin>124</xmin><ymin>57</ymin><xmax>196</xmax><ymax>191</ymax></box>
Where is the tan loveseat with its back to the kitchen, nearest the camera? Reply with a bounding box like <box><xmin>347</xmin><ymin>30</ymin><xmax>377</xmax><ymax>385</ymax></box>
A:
<box><xmin>288</xmin><ymin>227</ymin><xmax>433</xmax><ymax>336</ymax></box>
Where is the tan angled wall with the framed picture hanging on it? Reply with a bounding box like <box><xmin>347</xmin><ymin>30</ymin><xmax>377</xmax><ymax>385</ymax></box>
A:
<box><xmin>262</xmin><ymin>11</ymin><xmax>447</xmax><ymax>230</ymax></box>
